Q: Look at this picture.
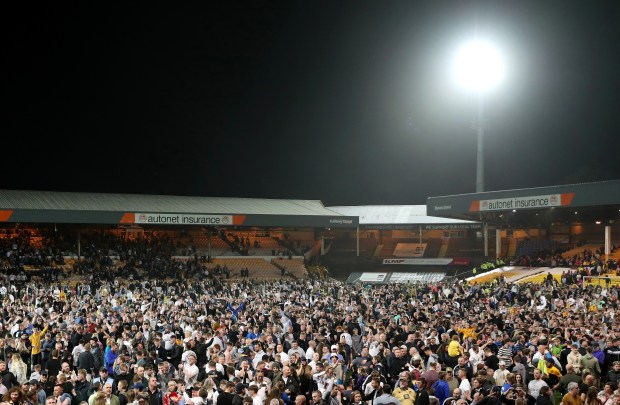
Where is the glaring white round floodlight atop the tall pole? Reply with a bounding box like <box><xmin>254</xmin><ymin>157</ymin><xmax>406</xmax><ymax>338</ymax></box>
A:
<box><xmin>454</xmin><ymin>40</ymin><xmax>505</xmax><ymax>92</ymax></box>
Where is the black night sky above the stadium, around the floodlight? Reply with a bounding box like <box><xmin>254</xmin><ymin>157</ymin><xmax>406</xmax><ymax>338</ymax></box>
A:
<box><xmin>0</xmin><ymin>0</ymin><xmax>620</xmax><ymax>205</ymax></box>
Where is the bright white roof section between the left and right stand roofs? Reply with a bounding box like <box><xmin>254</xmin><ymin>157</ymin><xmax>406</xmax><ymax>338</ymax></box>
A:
<box><xmin>328</xmin><ymin>205</ymin><xmax>481</xmax><ymax>229</ymax></box>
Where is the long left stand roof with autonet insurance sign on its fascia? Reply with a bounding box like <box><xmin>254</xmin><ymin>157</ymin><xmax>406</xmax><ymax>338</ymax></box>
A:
<box><xmin>0</xmin><ymin>190</ymin><xmax>358</xmax><ymax>228</ymax></box>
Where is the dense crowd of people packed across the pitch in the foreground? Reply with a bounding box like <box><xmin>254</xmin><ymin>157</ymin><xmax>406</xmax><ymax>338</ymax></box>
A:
<box><xmin>0</xmin><ymin>262</ymin><xmax>620</xmax><ymax>405</ymax></box>
